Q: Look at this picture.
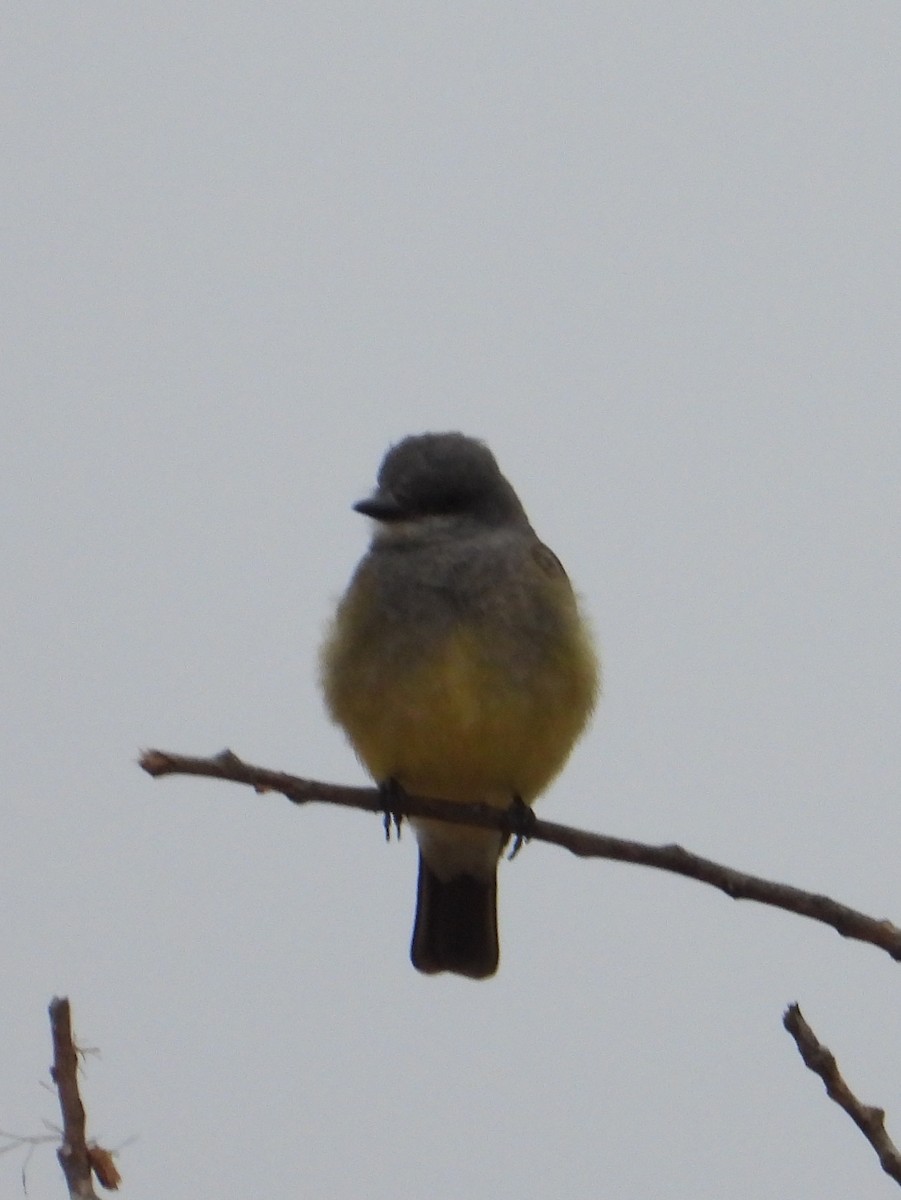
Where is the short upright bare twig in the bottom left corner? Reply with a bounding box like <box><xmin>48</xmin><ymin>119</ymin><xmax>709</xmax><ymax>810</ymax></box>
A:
<box><xmin>49</xmin><ymin>996</ymin><xmax>120</xmax><ymax>1200</ymax></box>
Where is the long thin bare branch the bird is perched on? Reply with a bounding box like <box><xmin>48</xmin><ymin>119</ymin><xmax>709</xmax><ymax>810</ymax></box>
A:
<box><xmin>139</xmin><ymin>750</ymin><xmax>901</xmax><ymax>961</ymax></box>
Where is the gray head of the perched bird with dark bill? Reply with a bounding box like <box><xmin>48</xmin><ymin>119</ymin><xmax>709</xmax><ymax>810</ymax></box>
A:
<box><xmin>354</xmin><ymin>433</ymin><xmax>528</xmax><ymax>524</ymax></box>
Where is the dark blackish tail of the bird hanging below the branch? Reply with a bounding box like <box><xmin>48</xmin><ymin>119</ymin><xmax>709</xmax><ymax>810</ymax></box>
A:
<box><xmin>410</xmin><ymin>853</ymin><xmax>498</xmax><ymax>979</ymax></box>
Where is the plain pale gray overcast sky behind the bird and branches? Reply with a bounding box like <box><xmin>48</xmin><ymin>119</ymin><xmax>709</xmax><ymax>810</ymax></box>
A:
<box><xmin>0</xmin><ymin>0</ymin><xmax>901</xmax><ymax>1200</ymax></box>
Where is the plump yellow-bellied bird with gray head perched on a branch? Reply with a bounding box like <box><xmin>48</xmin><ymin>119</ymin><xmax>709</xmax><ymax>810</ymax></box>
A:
<box><xmin>320</xmin><ymin>432</ymin><xmax>600</xmax><ymax>979</ymax></box>
